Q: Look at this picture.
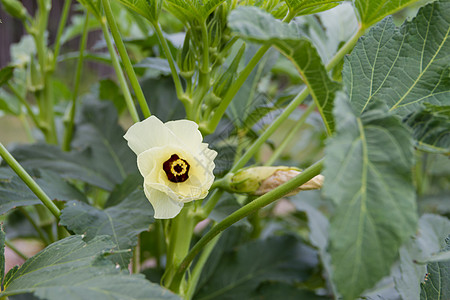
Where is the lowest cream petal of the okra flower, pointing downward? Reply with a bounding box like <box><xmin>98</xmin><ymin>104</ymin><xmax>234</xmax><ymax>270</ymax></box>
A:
<box><xmin>144</xmin><ymin>184</ymin><xmax>183</xmax><ymax>219</ymax></box>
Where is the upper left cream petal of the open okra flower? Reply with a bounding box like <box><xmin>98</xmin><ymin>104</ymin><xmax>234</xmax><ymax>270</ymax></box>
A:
<box><xmin>123</xmin><ymin>116</ymin><xmax>177</xmax><ymax>155</ymax></box>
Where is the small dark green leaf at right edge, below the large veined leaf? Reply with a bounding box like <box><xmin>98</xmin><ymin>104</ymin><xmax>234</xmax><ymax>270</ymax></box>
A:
<box><xmin>404</xmin><ymin>103</ymin><xmax>450</xmax><ymax>154</ymax></box>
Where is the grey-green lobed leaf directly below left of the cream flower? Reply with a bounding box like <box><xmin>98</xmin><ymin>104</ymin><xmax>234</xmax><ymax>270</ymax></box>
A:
<box><xmin>60</xmin><ymin>191</ymin><xmax>153</xmax><ymax>268</ymax></box>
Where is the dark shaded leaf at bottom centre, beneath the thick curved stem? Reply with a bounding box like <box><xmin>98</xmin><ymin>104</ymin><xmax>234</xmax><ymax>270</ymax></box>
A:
<box><xmin>195</xmin><ymin>236</ymin><xmax>317</xmax><ymax>300</ymax></box>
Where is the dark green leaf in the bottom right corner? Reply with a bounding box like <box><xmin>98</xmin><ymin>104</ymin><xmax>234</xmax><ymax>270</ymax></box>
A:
<box><xmin>420</xmin><ymin>235</ymin><xmax>450</xmax><ymax>300</ymax></box>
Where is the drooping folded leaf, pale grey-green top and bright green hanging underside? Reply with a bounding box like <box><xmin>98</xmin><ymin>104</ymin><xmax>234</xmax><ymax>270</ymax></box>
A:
<box><xmin>228</xmin><ymin>7</ymin><xmax>339</xmax><ymax>133</ymax></box>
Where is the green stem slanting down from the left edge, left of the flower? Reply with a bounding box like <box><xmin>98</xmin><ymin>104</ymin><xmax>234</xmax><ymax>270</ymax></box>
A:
<box><xmin>0</xmin><ymin>143</ymin><xmax>61</xmax><ymax>220</ymax></box>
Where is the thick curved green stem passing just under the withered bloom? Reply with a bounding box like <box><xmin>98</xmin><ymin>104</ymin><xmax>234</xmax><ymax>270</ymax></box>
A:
<box><xmin>174</xmin><ymin>159</ymin><xmax>323</xmax><ymax>280</ymax></box>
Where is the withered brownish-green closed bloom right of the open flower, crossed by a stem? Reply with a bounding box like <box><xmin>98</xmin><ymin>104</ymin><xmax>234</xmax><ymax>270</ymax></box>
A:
<box><xmin>226</xmin><ymin>166</ymin><xmax>323</xmax><ymax>196</ymax></box>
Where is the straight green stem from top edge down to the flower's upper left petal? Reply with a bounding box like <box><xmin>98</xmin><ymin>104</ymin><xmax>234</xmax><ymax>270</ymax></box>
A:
<box><xmin>102</xmin><ymin>0</ymin><xmax>151</xmax><ymax>118</ymax></box>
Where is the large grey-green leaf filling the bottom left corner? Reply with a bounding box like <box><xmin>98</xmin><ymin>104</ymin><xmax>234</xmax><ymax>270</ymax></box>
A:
<box><xmin>0</xmin><ymin>236</ymin><xmax>179</xmax><ymax>300</ymax></box>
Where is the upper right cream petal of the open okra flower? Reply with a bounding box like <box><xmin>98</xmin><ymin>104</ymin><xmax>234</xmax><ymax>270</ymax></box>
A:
<box><xmin>165</xmin><ymin>120</ymin><xmax>203</xmax><ymax>151</ymax></box>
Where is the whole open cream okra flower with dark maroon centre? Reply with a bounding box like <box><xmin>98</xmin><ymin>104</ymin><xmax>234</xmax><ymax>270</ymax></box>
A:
<box><xmin>124</xmin><ymin>116</ymin><xmax>217</xmax><ymax>219</ymax></box>
